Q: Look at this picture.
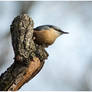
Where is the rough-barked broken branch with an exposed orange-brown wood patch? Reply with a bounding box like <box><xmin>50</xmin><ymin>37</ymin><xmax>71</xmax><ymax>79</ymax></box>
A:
<box><xmin>0</xmin><ymin>14</ymin><xmax>48</xmax><ymax>91</ymax></box>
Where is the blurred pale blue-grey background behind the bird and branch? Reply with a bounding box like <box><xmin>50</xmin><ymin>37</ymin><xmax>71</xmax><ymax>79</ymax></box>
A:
<box><xmin>0</xmin><ymin>1</ymin><xmax>92</xmax><ymax>91</ymax></box>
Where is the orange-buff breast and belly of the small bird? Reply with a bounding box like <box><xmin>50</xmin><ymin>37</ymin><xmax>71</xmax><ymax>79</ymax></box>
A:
<box><xmin>34</xmin><ymin>30</ymin><xmax>56</xmax><ymax>45</ymax></box>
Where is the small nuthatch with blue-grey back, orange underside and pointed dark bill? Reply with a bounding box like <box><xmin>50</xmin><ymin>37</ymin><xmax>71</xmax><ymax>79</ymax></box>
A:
<box><xmin>34</xmin><ymin>25</ymin><xmax>68</xmax><ymax>47</ymax></box>
